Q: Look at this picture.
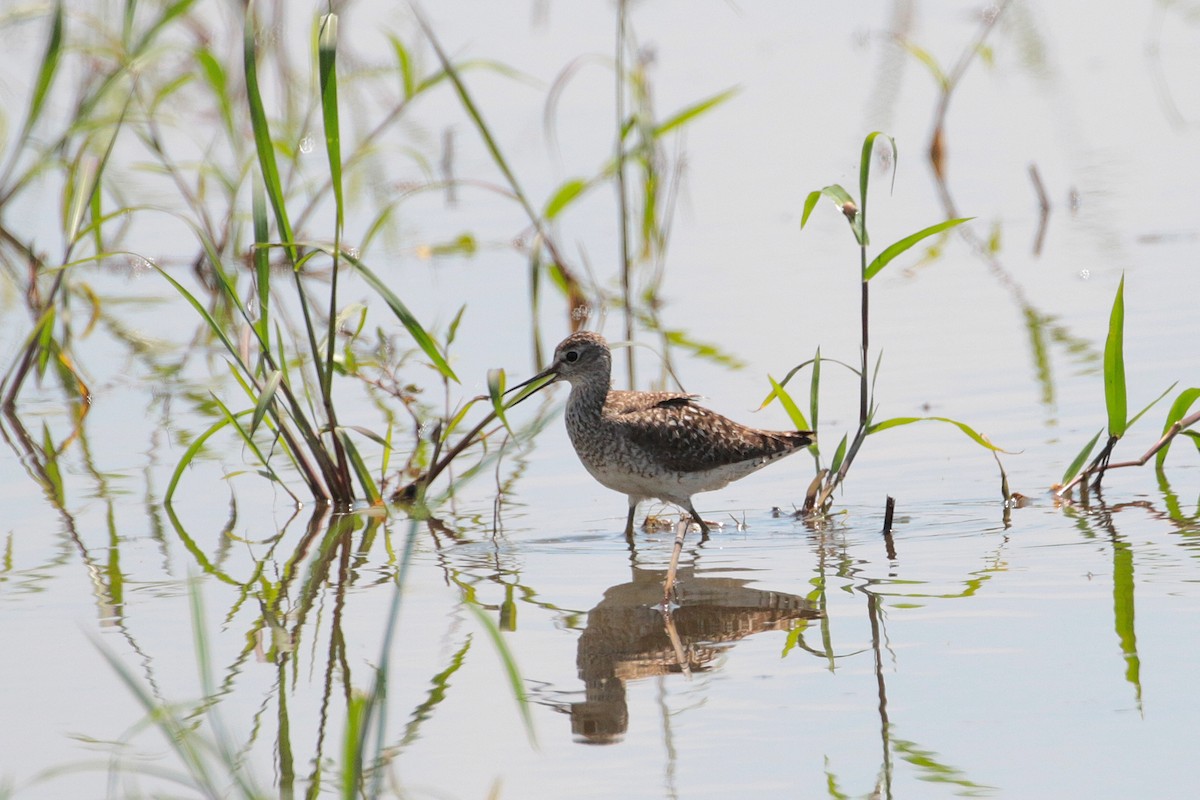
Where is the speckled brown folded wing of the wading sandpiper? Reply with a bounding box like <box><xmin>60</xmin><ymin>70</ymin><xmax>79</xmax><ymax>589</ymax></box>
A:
<box><xmin>608</xmin><ymin>392</ymin><xmax>812</xmax><ymax>471</ymax></box>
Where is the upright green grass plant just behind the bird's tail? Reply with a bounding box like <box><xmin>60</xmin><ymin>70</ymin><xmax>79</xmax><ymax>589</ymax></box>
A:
<box><xmin>762</xmin><ymin>131</ymin><xmax>1008</xmax><ymax>515</ymax></box>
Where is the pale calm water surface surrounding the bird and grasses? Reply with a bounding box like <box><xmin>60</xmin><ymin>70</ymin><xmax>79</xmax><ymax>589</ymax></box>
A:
<box><xmin>0</xmin><ymin>1</ymin><xmax>1200</xmax><ymax>798</ymax></box>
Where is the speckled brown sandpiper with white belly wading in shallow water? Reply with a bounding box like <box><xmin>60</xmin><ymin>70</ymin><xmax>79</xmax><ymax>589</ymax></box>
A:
<box><xmin>514</xmin><ymin>331</ymin><xmax>812</xmax><ymax>591</ymax></box>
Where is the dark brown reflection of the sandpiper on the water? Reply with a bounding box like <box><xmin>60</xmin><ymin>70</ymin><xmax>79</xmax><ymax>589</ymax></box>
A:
<box><xmin>570</xmin><ymin>556</ymin><xmax>821</xmax><ymax>744</ymax></box>
